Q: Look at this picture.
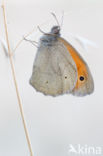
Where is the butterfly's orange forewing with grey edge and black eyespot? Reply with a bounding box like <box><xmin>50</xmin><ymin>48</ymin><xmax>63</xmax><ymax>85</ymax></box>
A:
<box><xmin>59</xmin><ymin>38</ymin><xmax>94</xmax><ymax>96</ymax></box>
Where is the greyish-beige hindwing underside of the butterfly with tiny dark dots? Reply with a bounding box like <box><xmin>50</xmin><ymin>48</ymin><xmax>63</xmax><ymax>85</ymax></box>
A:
<box><xmin>30</xmin><ymin>41</ymin><xmax>77</xmax><ymax>96</ymax></box>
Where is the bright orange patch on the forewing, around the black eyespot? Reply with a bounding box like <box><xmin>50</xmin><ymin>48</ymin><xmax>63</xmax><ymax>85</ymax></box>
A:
<box><xmin>58</xmin><ymin>37</ymin><xmax>87</xmax><ymax>89</ymax></box>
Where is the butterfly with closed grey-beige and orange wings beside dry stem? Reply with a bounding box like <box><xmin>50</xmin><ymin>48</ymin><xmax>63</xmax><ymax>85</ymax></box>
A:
<box><xmin>30</xmin><ymin>16</ymin><xmax>94</xmax><ymax>96</ymax></box>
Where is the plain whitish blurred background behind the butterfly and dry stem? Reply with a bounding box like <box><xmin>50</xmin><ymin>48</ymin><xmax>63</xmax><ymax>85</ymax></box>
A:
<box><xmin>0</xmin><ymin>0</ymin><xmax>103</xmax><ymax>156</ymax></box>
